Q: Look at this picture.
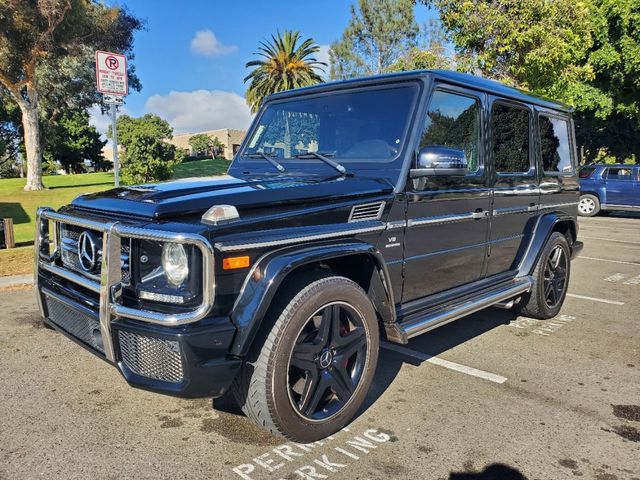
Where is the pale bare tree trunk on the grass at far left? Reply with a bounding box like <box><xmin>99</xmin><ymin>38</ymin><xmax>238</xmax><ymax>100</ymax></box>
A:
<box><xmin>18</xmin><ymin>86</ymin><xmax>44</xmax><ymax>192</ymax></box>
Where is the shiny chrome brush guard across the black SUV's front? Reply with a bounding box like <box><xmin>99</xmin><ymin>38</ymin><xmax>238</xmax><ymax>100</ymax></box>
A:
<box><xmin>36</xmin><ymin>209</ymin><xmax>215</xmax><ymax>330</ymax></box>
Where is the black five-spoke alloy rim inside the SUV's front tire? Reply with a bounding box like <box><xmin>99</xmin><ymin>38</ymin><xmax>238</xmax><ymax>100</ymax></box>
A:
<box><xmin>287</xmin><ymin>302</ymin><xmax>367</xmax><ymax>421</ymax></box>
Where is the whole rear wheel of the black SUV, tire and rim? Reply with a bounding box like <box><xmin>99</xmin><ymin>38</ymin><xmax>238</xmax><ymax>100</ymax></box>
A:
<box><xmin>514</xmin><ymin>232</ymin><xmax>571</xmax><ymax>320</ymax></box>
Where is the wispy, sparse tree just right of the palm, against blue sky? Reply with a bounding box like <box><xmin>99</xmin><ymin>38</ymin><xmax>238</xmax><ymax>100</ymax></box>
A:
<box><xmin>329</xmin><ymin>0</ymin><xmax>420</xmax><ymax>79</ymax></box>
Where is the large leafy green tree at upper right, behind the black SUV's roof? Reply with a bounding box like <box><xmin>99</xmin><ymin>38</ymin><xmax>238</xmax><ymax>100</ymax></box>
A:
<box><xmin>424</xmin><ymin>0</ymin><xmax>640</xmax><ymax>160</ymax></box>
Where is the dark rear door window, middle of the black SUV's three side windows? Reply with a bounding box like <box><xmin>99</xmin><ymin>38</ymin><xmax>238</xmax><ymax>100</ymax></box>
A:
<box><xmin>491</xmin><ymin>102</ymin><xmax>531</xmax><ymax>173</ymax></box>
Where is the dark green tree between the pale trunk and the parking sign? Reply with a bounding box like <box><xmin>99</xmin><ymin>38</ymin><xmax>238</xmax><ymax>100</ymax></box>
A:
<box><xmin>44</xmin><ymin>110</ymin><xmax>107</xmax><ymax>173</ymax></box>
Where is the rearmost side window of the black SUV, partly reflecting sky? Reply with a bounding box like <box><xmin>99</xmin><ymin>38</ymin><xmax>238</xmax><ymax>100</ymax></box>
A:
<box><xmin>538</xmin><ymin>115</ymin><xmax>573</xmax><ymax>173</ymax></box>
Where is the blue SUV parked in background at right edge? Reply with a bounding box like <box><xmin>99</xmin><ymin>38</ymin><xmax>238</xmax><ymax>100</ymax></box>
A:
<box><xmin>578</xmin><ymin>164</ymin><xmax>640</xmax><ymax>217</ymax></box>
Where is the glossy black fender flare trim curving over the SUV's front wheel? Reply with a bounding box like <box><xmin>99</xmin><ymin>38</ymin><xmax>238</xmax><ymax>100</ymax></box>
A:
<box><xmin>229</xmin><ymin>241</ymin><xmax>396</xmax><ymax>356</ymax></box>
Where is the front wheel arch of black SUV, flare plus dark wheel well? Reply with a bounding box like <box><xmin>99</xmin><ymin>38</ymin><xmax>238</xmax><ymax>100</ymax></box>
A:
<box><xmin>229</xmin><ymin>241</ymin><xmax>395</xmax><ymax>356</ymax></box>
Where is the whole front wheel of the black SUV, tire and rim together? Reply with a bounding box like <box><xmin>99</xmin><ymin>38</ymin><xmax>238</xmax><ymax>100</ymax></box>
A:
<box><xmin>231</xmin><ymin>276</ymin><xmax>379</xmax><ymax>443</ymax></box>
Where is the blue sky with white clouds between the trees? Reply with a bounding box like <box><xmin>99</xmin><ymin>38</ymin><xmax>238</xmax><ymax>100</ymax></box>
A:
<box><xmin>92</xmin><ymin>0</ymin><xmax>434</xmax><ymax>133</ymax></box>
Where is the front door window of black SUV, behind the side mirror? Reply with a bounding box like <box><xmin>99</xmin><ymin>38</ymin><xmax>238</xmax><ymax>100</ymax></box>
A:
<box><xmin>420</xmin><ymin>90</ymin><xmax>480</xmax><ymax>173</ymax></box>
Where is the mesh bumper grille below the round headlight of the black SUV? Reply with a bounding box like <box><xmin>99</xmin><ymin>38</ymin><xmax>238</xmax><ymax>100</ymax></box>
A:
<box><xmin>118</xmin><ymin>330</ymin><xmax>183</xmax><ymax>383</ymax></box>
